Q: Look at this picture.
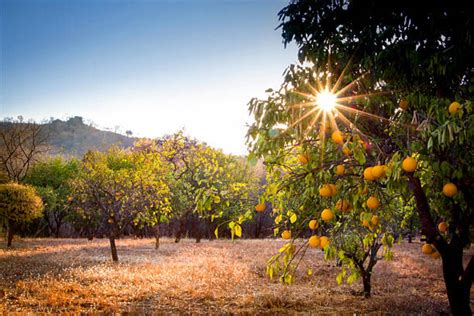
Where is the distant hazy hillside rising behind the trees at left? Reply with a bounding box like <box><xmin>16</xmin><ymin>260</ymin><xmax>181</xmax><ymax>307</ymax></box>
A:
<box><xmin>0</xmin><ymin>116</ymin><xmax>137</xmax><ymax>157</ymax></box>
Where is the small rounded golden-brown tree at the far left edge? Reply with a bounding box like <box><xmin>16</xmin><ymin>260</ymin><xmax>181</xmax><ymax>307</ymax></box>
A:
<box><xmin>0</xmin><ymin>183</ymin><xmax>43</xmax><ymax>247</ymax></box>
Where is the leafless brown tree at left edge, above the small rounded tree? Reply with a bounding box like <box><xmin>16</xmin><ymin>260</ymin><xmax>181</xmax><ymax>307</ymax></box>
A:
<box><xmin>0</xmin><ymin>116</ymin><xmax>49</xmax><ymax>182</ymax></box>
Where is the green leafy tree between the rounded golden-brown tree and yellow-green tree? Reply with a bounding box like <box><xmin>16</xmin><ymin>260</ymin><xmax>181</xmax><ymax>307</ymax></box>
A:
<box><xmin>24</xmin><ymin>157</ymin><xmax>79</xmax><ymax>237</ymax></box>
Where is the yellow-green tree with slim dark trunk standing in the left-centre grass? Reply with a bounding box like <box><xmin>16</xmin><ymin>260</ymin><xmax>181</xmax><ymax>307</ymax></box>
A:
<box><xmin>73</xmin><ymin>148</ymin><xmax>169</xmax><ymax>261</ymax></box>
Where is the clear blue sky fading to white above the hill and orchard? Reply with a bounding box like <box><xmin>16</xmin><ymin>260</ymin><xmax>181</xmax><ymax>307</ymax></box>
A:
<box><xmin>0</xmin><ymin>0</ymin><xmax>296</xmax><ymax>154</ymax></box>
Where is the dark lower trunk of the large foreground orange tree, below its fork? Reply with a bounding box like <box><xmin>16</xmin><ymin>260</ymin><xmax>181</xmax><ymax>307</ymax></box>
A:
<box><xmin>443</xmin><ymin>248</ymin><xmax>472</xmax><ymax>315</ymax></box>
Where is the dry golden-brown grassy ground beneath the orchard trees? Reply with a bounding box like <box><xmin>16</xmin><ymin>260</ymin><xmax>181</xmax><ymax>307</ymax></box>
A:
<box><xmin>0</xmin><ymin>239</ymin><xmax>470</xmax><ymax>314</ymax></box>
